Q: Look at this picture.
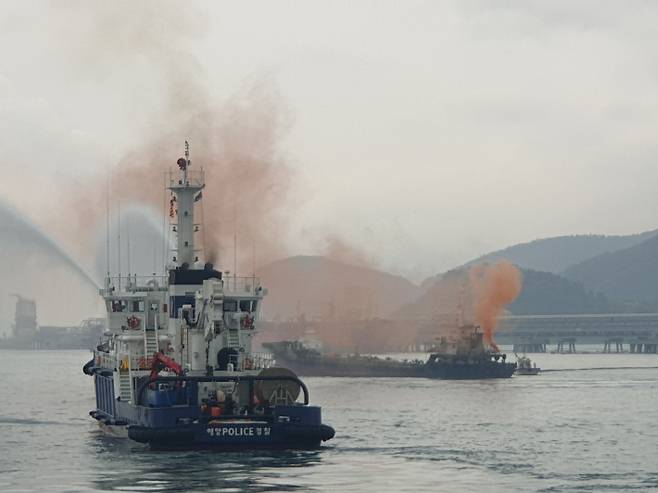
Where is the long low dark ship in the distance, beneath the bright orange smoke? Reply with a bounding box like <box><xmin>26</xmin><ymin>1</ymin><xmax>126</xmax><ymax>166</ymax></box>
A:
<box><xmin>263</xmin><ymin>325</ymin><xmax>516</xmax><ymax>380</ymax></box>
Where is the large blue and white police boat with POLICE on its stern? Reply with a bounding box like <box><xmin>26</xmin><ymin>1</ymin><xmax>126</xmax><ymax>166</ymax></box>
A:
<box><xmin>83</xmin><ymin>142</ymin><xmax>334</xmax><ymax>449</ymax></box>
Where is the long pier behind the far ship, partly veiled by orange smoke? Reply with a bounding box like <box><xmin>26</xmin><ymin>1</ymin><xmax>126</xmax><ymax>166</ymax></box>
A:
<box><xmin>263</xmin><ymin>313</ymin><xmax>658</xmax><ymax>354</ymax></box>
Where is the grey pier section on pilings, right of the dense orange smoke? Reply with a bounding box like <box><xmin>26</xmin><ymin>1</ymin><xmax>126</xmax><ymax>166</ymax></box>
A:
<box><xmin>496</xmin><ymin>313</ymin><xmax>658</xmax><ymax>353</ymax></box>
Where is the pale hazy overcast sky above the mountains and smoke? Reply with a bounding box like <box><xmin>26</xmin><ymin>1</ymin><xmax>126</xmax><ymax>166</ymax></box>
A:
<box><xmin>0</xmin><ymin>0</ymin><xmax>658</xmax><ymax>280</ymax></box>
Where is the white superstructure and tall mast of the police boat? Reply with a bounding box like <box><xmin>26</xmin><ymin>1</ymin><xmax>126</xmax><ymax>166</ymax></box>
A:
<box><xmin>96</xmin><ymin>142</ymin><xmax>270</xmax><ymax>402</ymax></box>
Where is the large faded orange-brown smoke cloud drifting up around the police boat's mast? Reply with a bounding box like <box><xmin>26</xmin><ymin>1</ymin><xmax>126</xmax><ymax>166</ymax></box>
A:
<box><xmin>40</xmin><ymin>2</ymin><xmax>293</xmax><ymax>275</ymax></box>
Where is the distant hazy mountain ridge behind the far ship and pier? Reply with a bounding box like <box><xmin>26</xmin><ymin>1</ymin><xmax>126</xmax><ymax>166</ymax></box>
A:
<box><xmin>259</xmin><ymin>230</ymin><xmax>658</xmax><ymax>320</ymax></box>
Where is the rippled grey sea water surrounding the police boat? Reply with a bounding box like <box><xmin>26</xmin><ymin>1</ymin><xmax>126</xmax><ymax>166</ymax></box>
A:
<box><xmin>0</xmin><ymin>350</ymin><xmax>658</xmax><ymax>492</ymax></box>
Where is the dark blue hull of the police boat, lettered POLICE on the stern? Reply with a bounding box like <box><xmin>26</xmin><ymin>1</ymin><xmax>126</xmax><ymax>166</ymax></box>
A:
<box><xmin>87</xmin><ymin>368</ymin><xmax>334</xmax><ymax>450</ymax></box>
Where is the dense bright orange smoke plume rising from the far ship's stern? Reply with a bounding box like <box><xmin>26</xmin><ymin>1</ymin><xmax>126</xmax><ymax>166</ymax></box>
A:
<box><xmin>469</xmin><ymin>260</ymin><xmax>522</xmax><ymax>350</ymax></box>
